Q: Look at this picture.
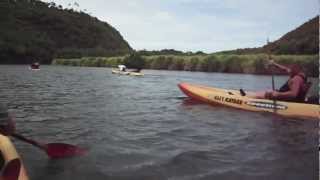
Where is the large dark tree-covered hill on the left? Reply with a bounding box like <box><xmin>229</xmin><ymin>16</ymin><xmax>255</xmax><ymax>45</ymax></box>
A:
<box><xmin>0</xmin><ymin>0</ymin><xmax>132</xmax><ymax>64</ymax></box>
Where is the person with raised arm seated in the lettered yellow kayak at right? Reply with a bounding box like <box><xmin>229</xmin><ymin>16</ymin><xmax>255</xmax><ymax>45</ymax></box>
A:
<box><xmin>240</xmin><ymin>60</ymin><xmax>311</xmax><ymax>102</ymax></box>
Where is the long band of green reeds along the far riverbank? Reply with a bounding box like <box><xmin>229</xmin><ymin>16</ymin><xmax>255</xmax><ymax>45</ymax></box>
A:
<box><xmin>53</xmin><ymin>54</ymin><xmax>319</xmax><ymax>77</ymax></box>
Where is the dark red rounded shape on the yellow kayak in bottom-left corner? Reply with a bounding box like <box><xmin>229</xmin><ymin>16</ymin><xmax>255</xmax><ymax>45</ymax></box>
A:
<box><xmin>0</xmin><ymin>159</ymin><xmax>21</xmax><ymax>180</ymax></box>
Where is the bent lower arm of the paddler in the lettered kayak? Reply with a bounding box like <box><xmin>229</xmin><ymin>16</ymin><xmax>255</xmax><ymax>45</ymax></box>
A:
<box><xmin>272</xmin><ymin>76</ymin><xmax>303</xmax><ymax>99</ymax></box>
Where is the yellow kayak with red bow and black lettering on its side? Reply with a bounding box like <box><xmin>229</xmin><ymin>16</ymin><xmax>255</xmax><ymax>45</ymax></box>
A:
<box><xmin>178</xmin><ymin>83</ymin><xmax>320</xmax><ymax>119</ymax></box>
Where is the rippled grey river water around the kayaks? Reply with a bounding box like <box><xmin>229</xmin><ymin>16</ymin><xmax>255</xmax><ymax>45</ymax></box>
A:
<box><xmin>0</xmin><ymin>65</ymin><xmax>318</xmax><ymax>180</ymax></box>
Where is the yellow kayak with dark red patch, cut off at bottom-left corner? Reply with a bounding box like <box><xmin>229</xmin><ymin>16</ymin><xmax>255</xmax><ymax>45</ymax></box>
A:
<box><xmin>0</xmin><ymin>134</ymin><xmax>29</xmax><ymax>180</ymax></box>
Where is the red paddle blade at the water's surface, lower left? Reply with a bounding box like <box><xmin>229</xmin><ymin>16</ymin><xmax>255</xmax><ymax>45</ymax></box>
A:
<box><xmin>45</xmin><ymin>143</ymin><xmax>87</xmax><ymax>159</ymax></box>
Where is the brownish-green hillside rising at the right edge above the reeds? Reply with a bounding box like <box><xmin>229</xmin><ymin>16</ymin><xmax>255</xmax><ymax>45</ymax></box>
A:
<box><xmin>218</xmin><ymin>16</ymin><xmax>319</xmax><ymax>55</ymax></box>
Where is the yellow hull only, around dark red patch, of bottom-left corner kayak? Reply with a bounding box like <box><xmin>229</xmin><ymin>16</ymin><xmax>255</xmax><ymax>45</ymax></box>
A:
<box><xmin>0</xmin><ymin>134</ymin><xmax>29</xmax><ymax>180</ymax></box>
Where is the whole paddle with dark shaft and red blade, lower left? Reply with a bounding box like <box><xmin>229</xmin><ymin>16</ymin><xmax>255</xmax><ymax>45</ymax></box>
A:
<box><xmin>8</xmin><ymin>117</ymin><xmax>87</xmax><ymax>159</ymax></box>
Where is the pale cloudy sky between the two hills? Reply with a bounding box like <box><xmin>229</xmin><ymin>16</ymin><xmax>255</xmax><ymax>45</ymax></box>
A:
<box><xmin>43</xmin><ymin>0</ymin><xmax>320</xmax><ymax>53</ymax></box>
